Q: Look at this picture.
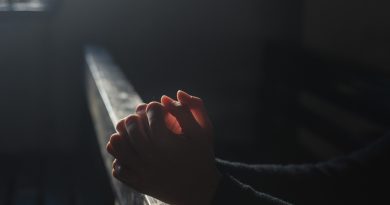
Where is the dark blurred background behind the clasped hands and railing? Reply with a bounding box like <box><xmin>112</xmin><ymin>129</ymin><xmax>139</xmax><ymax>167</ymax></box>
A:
<box><xmin>0</xmin><ymin>0</ymin><xmax>390</xmax><ymax>203</ymax></box>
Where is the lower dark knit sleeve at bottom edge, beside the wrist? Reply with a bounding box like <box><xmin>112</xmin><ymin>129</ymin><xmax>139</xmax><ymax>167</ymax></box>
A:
<box><xmin>212</xmin><ymin>174</ymin><xmax>289</xmax><ymax>205</ymax></box>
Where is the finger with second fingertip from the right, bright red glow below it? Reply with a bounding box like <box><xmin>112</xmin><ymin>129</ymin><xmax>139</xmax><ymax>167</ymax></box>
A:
<box><xmin>161</xmin><ymin>96</ymin><xmax>199</xmax><ymax>133</ymax></box>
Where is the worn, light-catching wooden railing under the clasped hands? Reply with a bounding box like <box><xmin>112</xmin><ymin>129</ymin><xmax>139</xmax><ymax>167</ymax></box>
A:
<box><xmin>85</xmin><ymin>46</ymin><xmax>164</xmax><ymax>205</ymax></box>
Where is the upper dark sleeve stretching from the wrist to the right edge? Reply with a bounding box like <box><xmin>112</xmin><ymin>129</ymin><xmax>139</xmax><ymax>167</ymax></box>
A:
<box><xmin>217</xmin><ymin>132</ymin><xmax>390</xmax><ymax>204</ymax></box>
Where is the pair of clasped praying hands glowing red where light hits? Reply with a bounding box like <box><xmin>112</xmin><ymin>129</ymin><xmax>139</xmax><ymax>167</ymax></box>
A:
<box><xmin>107</xmin><ymin>91</ymin><xmax>221</xmax><ymax>205</ymax></box>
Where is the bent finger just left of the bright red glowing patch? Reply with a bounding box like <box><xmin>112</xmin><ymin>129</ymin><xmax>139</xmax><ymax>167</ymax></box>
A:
<box><xmin>146</xmin><ymin>102</ymin><xmax>170</xmax><ymax>137</ymax></box>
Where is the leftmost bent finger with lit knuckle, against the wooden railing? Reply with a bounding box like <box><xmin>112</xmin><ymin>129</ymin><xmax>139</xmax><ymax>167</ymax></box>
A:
<box><xmin>109</xmin><ymin>133</ymin><xmax>138</xmax><ymax>167</ymax></box>
